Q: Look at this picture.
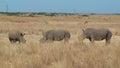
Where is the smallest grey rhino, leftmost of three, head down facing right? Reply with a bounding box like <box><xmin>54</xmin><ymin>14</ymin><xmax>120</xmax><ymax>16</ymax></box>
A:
<box><xmin>8</xmin><ymin>31</ymin><xmax>26</xmax><ymax>43</ymax></box>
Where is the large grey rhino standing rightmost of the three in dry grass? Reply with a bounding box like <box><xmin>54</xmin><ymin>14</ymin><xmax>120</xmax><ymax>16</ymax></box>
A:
<box><xmin>82</xmin><ymin>28</ymin><xmax>112</xmax><ymax>44</ymax></box>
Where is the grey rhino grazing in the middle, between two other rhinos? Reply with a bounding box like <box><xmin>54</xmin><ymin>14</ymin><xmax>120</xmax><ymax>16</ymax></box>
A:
<box><xmin>40</xmin><ymin>30</ymin><xmax>70</xmax><ymax>42</ymax></box>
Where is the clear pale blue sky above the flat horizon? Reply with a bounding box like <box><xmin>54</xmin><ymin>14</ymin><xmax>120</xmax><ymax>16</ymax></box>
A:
<box><xmin>0</xmin><ymin>0</ymin><xmax>120</xmax><ymax>14</ymax></box>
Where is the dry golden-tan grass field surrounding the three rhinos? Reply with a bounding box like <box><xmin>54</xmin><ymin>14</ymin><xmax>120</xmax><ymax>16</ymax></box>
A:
<box><xmin>0</xmin><ymin>14</ymin><xmax>120</xmax><ymax>68</ymax></box>
